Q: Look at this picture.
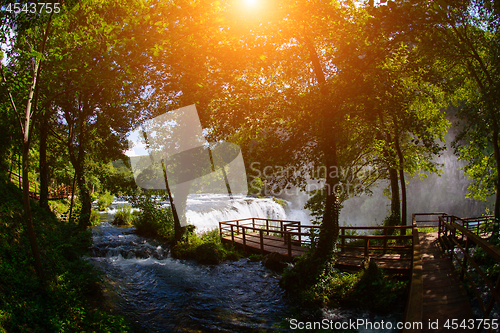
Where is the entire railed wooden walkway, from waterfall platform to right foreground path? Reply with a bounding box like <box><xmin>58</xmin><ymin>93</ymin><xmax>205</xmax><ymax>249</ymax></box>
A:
<box><xmin>219</xmin><ymin>213</ymin><xmax>500</xmax><ymax>333</ymax></box>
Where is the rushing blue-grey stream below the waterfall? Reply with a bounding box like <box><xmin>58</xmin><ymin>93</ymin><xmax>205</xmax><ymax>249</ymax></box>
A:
<box><xmin>90</xmin><ymin>199</ymin><xmax>402</xmax><ymax>332</ymax></box>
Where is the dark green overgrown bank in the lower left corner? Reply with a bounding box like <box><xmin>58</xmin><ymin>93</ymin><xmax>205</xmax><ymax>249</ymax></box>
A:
<box><xmin>0</xmin><ymin>174</ymin><xmax>129</xmax><ymax>332</ymax></box>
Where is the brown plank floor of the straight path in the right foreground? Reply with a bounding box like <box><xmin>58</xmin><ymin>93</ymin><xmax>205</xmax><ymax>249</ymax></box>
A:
<box><xmin>419</xmin><ymin>232</ymin><xmax>476</xmax><ymax>332</ymax></box>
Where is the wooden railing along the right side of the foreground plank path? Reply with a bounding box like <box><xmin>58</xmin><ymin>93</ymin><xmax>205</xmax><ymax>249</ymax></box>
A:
<box><xmin>439</xmin><ymin>215</ymin><xmax>500</xmax><ymax>319</ymax></box>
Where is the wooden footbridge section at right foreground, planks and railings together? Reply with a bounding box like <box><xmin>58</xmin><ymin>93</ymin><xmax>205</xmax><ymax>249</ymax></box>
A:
<box><xmin>403</xmin><ymin>213</ymin><xmax>500</xmax><ymax>333</ymax></box>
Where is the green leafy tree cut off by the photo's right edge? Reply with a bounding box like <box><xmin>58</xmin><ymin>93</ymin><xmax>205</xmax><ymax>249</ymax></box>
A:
<box><xmin>416</xmin><ymin>0</ymin><xmax>500</xmax><ymax>235</ymax></box>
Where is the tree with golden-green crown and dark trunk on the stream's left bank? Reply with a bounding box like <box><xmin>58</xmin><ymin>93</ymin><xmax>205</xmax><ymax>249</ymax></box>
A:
<box><xmin>41</xmin><ymin>1</ymin><xmax>147</xmax><ymax>227</ymax></box>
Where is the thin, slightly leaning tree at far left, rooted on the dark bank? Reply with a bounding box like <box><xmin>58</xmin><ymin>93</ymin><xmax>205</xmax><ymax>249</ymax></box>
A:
<box><xmin>1</xmin><ymin>0</ymin><xmax>63</xmax><ymax>283</ymax></box>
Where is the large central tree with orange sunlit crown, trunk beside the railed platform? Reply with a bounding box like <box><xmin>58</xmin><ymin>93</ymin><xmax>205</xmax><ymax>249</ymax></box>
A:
<box><xmin>188</xmin><ymin>1</ymin><xmax>402</xmax><ymax>262</ymax></box>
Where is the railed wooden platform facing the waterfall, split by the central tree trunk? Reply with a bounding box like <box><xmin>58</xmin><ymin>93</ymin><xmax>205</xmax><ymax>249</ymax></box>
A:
<box><xmin>219</xmin><ymin>218</ymin><xmax>412</xmax><ymax>274</ymax></box>
